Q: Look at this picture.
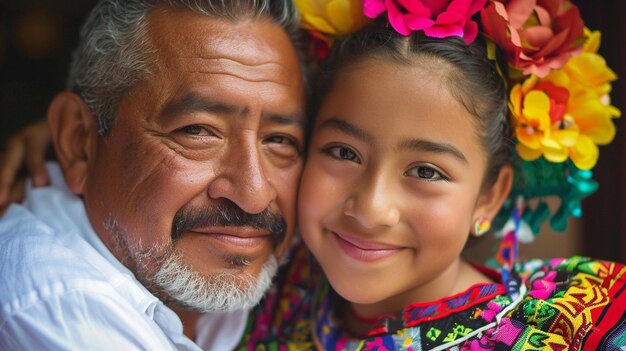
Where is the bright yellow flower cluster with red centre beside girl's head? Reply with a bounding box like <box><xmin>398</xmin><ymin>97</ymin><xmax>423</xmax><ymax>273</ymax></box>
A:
<box><xmin>510</xmin><ymin>39</ymin><xmax>620</xmax><ymax>170</ymax></box>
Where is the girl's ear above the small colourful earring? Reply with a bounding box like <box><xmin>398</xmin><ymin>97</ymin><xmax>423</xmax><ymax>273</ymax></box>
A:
<box><xmin>473</xmin><ymin>165</ymin><xmax>513</xmax><ymax>221</ymax></box>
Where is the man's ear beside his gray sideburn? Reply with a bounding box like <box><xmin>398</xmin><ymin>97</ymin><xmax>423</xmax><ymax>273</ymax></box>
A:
<box><xmin>48</xmin><ymin>91</ymin><xmax>98</xmax><ymax>194</ymax></box>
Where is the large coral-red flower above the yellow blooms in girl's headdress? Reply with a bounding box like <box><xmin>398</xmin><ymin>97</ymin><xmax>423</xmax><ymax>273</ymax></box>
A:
<box><xmin>481</xmin><ymin>0</ymin><xmax>585</xmax><ymax>78</ymax></box>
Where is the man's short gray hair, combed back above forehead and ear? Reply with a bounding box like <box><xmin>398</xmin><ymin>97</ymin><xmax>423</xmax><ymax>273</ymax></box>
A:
<box><xmin>67</xmin><ymin>0</ymin><xmax>303</xmax><ymax>135</ymax></box>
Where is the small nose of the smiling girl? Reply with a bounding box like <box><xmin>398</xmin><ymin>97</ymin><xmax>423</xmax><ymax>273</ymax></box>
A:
<box><xmin>344</xmin><ymin>174</ymin><xmax>400</xmax><ymax>229</ymax></box>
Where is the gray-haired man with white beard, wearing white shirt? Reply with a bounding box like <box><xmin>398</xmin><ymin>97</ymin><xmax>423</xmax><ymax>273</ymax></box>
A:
<box><xmin>0</xmin><ymin>0</ymin><xmax>305</xmax><ymax>350</ymax></box>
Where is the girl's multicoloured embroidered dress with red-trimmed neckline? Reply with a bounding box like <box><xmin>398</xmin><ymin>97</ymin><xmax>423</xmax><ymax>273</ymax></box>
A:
<box><xmin>239</xmin><ymin>247</ymin><xmax>626</xmax><ymax>351</ymax></box>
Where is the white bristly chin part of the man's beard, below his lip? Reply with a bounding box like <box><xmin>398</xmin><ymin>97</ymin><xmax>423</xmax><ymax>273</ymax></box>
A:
<box><xmin>150</xmin><ymin>252</ymin><xmax>278</xmax><ymax>312</ymax></box>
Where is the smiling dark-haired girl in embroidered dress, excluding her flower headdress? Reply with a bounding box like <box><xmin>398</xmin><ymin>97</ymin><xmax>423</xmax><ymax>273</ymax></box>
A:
<box><xmin>234</xmin><ymin>3</ymin><xmax>626</xmax><ymax>350</ymax></box>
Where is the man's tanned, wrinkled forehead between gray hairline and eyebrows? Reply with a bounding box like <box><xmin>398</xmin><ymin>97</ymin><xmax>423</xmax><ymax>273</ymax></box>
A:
<box><xmin>149</xmin><ymin>7</ymin><xmax>302</xmax><ymax>92</ymax></box>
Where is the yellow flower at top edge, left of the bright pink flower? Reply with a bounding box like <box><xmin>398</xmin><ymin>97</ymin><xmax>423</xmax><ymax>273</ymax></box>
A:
<box><xmin>294</xmin><ymin>0</ymin><xmax>371</xmax><ymax>36</ymax></box>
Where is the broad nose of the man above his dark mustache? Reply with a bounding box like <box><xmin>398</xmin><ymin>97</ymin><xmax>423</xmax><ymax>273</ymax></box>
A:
<box><xmin>208</xmin><ymin>142</ymin><xmax>276</xmax><ymax>213</ymax></box>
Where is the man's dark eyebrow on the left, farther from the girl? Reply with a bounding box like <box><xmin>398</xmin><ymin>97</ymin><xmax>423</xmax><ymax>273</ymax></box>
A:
<box><xmin>161</xmin><ymin>92</ymin><xmax>244</xmax><ymax>118</ymax></box>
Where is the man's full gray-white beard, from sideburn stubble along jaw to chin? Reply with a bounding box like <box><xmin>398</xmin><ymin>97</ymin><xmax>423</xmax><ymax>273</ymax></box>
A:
<box><xmin>105</xmin><ymin>216</ymin><xmax>278</xmax><ymax>312</ymax></box>
